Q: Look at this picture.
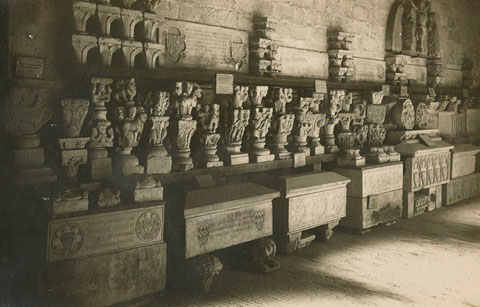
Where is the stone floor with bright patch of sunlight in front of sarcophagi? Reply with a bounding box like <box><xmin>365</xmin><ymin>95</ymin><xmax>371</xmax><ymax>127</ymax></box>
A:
<box><xmin>135</xmin><ymin>198</ymin><xmax>480</xmax><ymax>306</ymax></box>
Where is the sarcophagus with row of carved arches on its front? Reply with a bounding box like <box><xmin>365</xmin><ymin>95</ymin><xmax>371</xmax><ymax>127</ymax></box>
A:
<box><xmin>395</xmin><ymin>135</ymin><xmax>453</xmax><ymax>218</ymax></box>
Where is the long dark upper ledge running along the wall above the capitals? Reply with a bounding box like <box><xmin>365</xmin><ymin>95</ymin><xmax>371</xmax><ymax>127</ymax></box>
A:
<box><xmin>78</xmin><ymin>67</ymin><xmax>470</xmax><ymax>96</ymax></box>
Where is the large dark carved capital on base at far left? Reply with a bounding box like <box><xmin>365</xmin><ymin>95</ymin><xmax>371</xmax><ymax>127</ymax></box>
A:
<box><xmin>3</xmin><ymin>87</ymin><xmax>57</xmax><ymax>185</ymax></box>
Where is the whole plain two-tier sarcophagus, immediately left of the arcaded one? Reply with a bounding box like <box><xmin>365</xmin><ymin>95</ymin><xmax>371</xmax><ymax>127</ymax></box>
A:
<box><xmin>335</xmin><ymin>162</ymin><xmax>403</xmax><ymax>233</ymax></box>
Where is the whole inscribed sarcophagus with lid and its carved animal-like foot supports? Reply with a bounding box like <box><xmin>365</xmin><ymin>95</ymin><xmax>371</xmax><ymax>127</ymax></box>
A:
<box><xmin>171</xmin><ymin>183</ymin><xmax>280</xmax><ymax>293</ymax></box>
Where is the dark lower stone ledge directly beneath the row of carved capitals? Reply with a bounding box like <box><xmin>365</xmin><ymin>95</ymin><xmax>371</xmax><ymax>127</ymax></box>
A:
<box><xmin>154</xmin><ymin>154</ymin><xmax>336</xmax><ymax>185</ymax></box>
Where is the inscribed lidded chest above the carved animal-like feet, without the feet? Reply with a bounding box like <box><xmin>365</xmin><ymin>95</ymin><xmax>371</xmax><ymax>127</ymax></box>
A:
<box><xmin>185</xmin><ymin>183</ymin><xmax>280</xmax><ymax>258</ymax></box>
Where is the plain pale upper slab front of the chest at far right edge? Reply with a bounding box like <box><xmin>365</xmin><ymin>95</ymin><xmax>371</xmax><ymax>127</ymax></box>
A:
<box><xmin>452</xmin><ymin>144</ymin><xmax>480</xmax><ymax>179</ymax></box>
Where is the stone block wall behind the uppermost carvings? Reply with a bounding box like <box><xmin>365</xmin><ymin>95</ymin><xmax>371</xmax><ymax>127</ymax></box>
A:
<box><xmin>5</xmin><ymin>0</ymin><xmax>480</xmax><ymax>86</ymax></box>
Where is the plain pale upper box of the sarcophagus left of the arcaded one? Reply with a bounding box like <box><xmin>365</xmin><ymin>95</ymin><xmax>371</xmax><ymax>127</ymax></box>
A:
<box><xmin>334</xmin><ymin>162</ymin><xmax>403</xmax><ymax>198</ymax></box>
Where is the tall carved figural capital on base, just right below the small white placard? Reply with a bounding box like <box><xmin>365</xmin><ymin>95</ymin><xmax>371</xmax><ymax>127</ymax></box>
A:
<box><xmin>222</xmin><ymin>86</ymin><xmax>250</xmax><ymax>165</ymax></box>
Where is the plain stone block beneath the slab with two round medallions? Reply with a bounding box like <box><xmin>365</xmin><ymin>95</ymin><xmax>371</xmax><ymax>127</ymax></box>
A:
<box><xmin>46</xmin><ymin>243</ymin><xmax>167</xmax><ymax>306</ymax></box>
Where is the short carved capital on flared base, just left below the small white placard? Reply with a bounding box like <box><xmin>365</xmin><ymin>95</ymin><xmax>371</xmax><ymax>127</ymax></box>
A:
<box><xmin>196</xmin><ymin>104</ymin><xmax>223</xmax><ymax>168</ymax></box>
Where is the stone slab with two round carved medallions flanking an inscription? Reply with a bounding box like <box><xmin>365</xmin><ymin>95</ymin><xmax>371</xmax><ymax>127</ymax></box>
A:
<box><xmin>47</xmin><ymin>205</ymin><xmax>163</xmax><ymax>262</ymax></box>
